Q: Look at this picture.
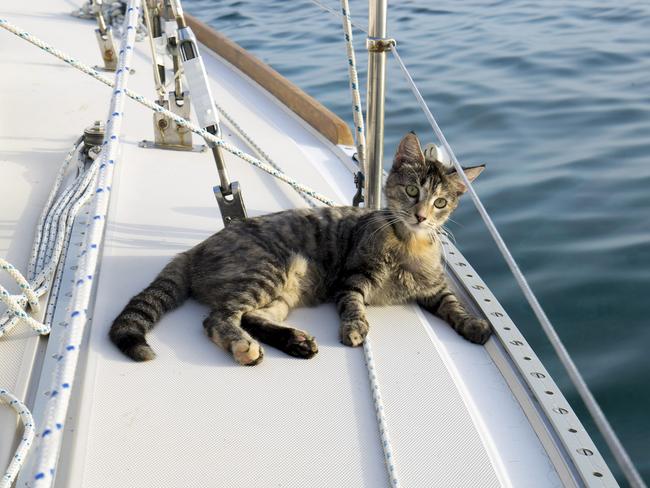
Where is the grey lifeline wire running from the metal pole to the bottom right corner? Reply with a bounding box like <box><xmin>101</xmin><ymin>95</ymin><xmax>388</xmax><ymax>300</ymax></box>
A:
<box><xmin>391</xmin><ymin>46</ymin><xmax>645</xmax><ymax>488</ymax></box>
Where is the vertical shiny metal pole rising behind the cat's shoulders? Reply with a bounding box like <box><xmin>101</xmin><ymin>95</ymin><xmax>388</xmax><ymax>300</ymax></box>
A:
<box><xmin>365</xmin><ymin>0</ymin><xmax>388</xmax><ymax>209</ymax></box>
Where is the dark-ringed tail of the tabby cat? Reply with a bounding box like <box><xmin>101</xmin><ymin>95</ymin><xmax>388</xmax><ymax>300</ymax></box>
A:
<box><xmin>108</xmin><ymin>253</ymin><xmax>190</xmax><ymax>361</ymax></box>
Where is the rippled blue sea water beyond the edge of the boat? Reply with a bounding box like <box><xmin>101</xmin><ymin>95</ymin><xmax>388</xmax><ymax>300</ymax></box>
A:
<box><xmin>185</xmin><ymin>0</ymin><xmax>650</xmax><ymax>483</ymax></box>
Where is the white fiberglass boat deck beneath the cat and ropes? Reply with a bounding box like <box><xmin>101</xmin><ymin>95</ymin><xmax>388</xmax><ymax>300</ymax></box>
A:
<box><xmin>0</xmin><ymin>0</ymin><xmax>560</xmax><ymax>488</ymax></box>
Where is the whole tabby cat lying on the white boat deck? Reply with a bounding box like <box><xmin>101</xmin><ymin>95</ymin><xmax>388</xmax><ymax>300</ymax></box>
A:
<box><xmin>110</xmin><ymin>133</ymin><xmax>491</xmax><ymax>365</ymax></box>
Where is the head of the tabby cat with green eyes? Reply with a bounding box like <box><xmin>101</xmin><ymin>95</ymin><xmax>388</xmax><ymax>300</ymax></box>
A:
<box><xmin>385</xmin><ymin>132</ymin><xmax>485</xmax><ymax>235</ymax></box>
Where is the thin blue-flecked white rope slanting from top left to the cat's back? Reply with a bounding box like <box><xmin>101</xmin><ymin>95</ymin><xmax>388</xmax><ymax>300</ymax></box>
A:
<box><xmin>0</xmin><ymin>18</ymin><xmax>334</xmax><ymax>205</ymax></box>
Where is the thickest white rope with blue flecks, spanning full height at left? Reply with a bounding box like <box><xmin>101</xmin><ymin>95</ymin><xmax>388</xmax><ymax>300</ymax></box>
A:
<box><xmin>28</xmin><ymin>0</ymin><xmax>140</xmax><ymax>488</ymax></box>
